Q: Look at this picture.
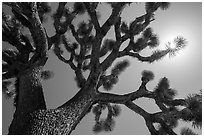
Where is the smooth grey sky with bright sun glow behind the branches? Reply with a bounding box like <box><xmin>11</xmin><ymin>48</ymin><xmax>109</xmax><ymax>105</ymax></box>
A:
<box><xmin>2</xmin><ymin>2</ymin><xmax>202</xmax><ymax>135</ymax></box>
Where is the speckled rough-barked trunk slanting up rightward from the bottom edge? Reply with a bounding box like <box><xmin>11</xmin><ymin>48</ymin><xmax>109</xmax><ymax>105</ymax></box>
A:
<box><xmin>26</xmin><ymin>88</ymin><xmax>94</xmax><ymax>135</ymax></box>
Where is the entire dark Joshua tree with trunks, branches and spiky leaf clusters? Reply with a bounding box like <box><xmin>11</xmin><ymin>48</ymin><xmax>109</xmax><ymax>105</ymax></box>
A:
<box><xmin>2</xmin><ymin>2</ymin><xmax>202</xmax><ymax>135</ymax></box>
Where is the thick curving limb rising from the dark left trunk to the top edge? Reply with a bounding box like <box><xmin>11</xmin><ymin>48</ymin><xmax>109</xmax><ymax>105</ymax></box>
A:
<box><xmin>4</xmin><ymin>2</ymin><xmax>48</xmax><ymax>64</ymax></box>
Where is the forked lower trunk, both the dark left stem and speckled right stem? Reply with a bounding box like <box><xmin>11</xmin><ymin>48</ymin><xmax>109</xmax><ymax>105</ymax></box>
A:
<box><xmin>9</xmin><ymin>67</ymin><xmax>95</xmax><ymax>135</ymax></box>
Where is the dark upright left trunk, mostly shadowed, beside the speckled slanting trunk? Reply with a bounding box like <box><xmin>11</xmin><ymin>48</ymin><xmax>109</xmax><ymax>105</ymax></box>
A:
<box><xmin>9</xmin><ymin>66</ymin><xmax>46</xmax><ymax>134</ymax></box>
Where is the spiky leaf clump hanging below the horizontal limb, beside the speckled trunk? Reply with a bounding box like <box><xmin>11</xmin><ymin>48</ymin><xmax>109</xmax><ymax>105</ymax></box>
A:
<box><xmin>93</xmin><ymin>103</ymin><xmax>120</xmax><ymax>133</ymax></box>
